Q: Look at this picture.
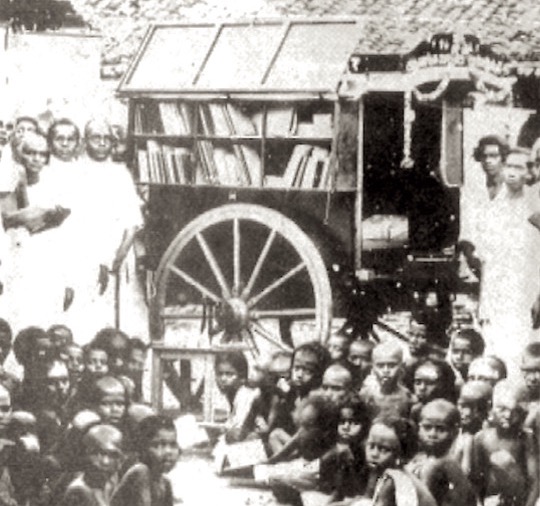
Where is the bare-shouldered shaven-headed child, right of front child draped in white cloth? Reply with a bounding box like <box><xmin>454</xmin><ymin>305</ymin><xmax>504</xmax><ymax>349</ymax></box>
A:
<box><xmin>406</xmin><ymin>399</ymin><xmax>476</xmax><ymax>506</ymax></box>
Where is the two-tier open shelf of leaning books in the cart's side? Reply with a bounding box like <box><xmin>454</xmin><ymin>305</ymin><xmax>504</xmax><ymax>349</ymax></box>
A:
<box><xmin>132</xmin><ymin>100</ymin><xmax>334</xmax><ymax>190</ymax></box>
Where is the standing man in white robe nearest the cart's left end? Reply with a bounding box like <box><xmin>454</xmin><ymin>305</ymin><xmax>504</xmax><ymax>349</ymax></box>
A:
<box><xmin>64</xmin><ymin>120</ymin><xmax>146</xmax><ymax>344</ymax></box>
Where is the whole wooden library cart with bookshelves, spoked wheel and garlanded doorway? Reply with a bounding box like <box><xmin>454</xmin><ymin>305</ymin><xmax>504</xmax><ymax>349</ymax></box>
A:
<box><xmin>118</xmin><ymin>18</ymin><xmax>537</xmax><ymax>424</ymax></box>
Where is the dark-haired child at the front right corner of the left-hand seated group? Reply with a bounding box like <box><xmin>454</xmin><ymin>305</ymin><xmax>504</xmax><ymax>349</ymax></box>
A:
<box><xmin>110</xmin><ymin>415</ymin><xmax>180</xmax><ymax>506</ymax></box>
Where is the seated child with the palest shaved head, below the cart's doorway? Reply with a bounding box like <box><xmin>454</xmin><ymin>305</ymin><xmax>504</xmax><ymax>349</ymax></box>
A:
<box><xmin>360</xmin><ymin>341</ymin><xmax>413</xmax><ymax>420</ymax></box>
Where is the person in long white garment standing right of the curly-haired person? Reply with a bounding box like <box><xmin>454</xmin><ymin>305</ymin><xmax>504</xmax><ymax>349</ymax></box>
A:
<box><xmin>476</xmin><ymin>148</ymin><xmax>540</xmax><ymax>378</ymax></box>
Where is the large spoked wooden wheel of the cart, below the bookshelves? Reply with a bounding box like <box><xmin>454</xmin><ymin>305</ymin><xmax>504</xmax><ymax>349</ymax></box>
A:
<box><xmin>153</xmin><ymin>203</ymin><xmax>332</xmax><ymax>351</ymax></box>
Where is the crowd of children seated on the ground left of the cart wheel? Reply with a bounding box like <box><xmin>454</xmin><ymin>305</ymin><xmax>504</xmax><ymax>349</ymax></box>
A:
<box><xmin>0</xmin><ymin>320</ymin><xmax>179</xmax><ymax>506</ymax></box>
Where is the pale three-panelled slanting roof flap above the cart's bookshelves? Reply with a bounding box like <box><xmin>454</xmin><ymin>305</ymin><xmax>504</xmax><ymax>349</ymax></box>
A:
<box><xmin>118</xmin><ymin>18</ymin><xmax>360</xmax><ymax>99</ymax></box>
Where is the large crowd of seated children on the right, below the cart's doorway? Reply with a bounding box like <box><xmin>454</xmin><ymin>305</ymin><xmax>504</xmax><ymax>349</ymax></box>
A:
<box><xmin>210</xmin><ymin>315</ymin><xmax>540</xmax><ymax>506</ymax></box>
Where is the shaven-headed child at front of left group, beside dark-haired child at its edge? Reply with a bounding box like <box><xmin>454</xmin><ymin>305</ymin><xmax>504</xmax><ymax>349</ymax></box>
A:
<box><xmin>59</xmin><ymin>424</ymin><xmax>122</xmax><ymax>506</ymax></box>
